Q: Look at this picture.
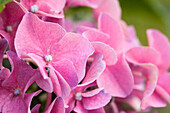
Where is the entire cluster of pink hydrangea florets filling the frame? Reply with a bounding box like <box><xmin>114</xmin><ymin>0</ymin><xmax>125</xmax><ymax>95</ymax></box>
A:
<box><xmin>0</xmin><ymin>0</ymin><xmax>170</xmax><ymax>113</ymax></box>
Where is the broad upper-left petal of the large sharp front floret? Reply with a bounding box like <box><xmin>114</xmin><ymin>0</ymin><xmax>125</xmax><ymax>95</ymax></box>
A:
<box><xmin>15</xmin><ymin>13</ymin><xmax>65</xmax><ymax>57</ymax></box>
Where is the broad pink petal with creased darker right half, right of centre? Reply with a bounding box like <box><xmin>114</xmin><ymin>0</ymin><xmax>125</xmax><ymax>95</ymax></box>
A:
<box><xmin>97</xmin><ymin>55</ymin><xmax>134</xmax><ymax>97</ymax></box>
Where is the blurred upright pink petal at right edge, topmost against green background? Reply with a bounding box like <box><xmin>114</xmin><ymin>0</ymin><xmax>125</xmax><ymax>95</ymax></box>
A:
<box><xmin>147</xmin><ymin>29</ymin><xmax>170</xmax><ymax>71</ymax></box>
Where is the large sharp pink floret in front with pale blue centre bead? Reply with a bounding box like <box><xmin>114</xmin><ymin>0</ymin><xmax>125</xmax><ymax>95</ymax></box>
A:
<box><xmin>15</xmin><ymin>13</ymin><xmax>93</xmax><ymax>96</ymax></box>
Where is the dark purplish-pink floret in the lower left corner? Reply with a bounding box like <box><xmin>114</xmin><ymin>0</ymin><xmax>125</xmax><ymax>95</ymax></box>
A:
<box><xmin>0</xmin><ymin>51</ymin><xmax>40</xmax><ymax>113</ymax></box>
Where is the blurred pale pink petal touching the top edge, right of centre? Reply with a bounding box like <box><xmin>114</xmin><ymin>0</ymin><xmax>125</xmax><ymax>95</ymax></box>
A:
<box><xmin>94</xmin><ymin>0</ymin><xmax>121</xmax><ymax>20</ymax></box>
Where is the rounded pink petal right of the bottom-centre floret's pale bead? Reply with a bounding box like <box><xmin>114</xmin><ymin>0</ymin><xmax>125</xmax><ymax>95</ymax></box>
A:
<box><xmin>82</xmin><ymin>90</ymin><xmax>111</xmax><ymax>110</ymax></box>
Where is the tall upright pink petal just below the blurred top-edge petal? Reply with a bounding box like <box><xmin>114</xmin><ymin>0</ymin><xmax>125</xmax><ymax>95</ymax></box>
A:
<box><xmin>98</xmin><ymin>13</ymin><xmax>125</xmax><ymax>53</ymax></box>
